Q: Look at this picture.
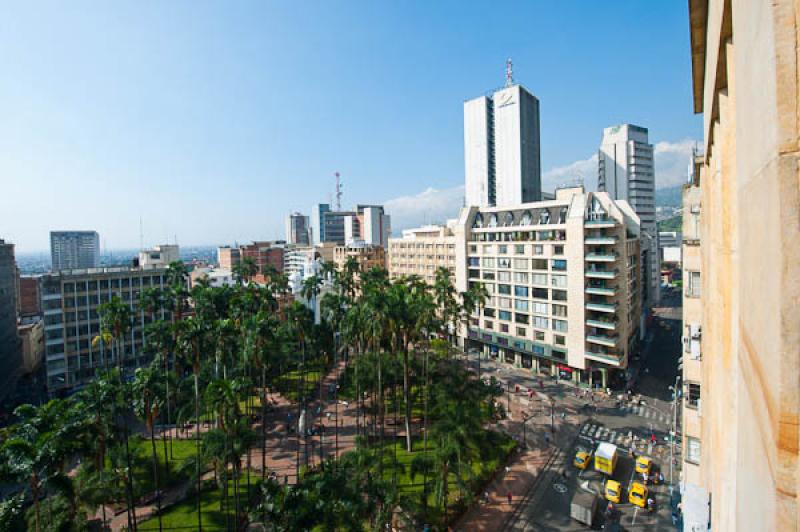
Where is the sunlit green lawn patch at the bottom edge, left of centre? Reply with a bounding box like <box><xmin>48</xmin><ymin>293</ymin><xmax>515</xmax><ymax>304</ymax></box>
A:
<box><xmin>139</xmin><ymin>473</ymin><xmax>256</xmax><ymax>530</ymax></box>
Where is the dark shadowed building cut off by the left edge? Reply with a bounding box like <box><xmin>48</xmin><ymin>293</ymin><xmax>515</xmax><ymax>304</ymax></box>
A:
<box><xmin>0</xmin><ymin>239</ymin><xmax>22</xmax><ymax>400</ymax></box>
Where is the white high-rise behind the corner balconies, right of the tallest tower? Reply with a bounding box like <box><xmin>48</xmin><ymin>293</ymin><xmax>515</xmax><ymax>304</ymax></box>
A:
<box><xmin>597</xmin><ymin>124</ymin><xmax>661</xmax><ymax>309</ymax></box>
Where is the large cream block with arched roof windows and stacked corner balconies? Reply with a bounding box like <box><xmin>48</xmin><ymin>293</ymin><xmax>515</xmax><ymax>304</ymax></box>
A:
<box><xmin>453</xmin><ymin>187</ymin><xmax>641</xmax><ymax>387</ymax></box>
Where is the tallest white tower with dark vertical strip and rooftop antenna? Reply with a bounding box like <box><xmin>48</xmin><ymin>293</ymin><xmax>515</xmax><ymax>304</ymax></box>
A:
<box><xmin>464</xmin><ymin>77</ymin><xmax>542</xmax><ymax>207</ymax></box>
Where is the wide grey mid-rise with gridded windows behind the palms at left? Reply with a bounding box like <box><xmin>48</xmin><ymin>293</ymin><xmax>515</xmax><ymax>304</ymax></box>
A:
<box><xmin>41</xmin><ymin>267</ymin><xmax>169</xmax><ymax>396</ymax></box>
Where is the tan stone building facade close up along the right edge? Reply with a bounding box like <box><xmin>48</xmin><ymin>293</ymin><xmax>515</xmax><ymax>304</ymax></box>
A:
<box><xmin>681</xmin><ymin>0</ymin><xmax>800</xmax><ymax>532</ymax></box>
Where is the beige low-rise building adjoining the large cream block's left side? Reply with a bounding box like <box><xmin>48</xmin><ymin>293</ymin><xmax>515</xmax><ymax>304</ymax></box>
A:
<box><xmin>386</xmin><ymin>220</ymin><xmax>456</xmax><ymax>284</ymax></box>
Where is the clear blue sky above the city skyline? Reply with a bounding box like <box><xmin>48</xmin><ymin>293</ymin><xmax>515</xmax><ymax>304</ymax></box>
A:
<box><xmin>0</xmin><ymin>0</ymin><xmax>701</xmax><ymax>252</ymax></box>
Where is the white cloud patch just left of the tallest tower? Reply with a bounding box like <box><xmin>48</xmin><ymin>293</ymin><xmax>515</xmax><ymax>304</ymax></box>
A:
<box><xmin>383</xmin><ymin>185</ymin><xmax>464</xmax><ymax>234</ymax></box>
